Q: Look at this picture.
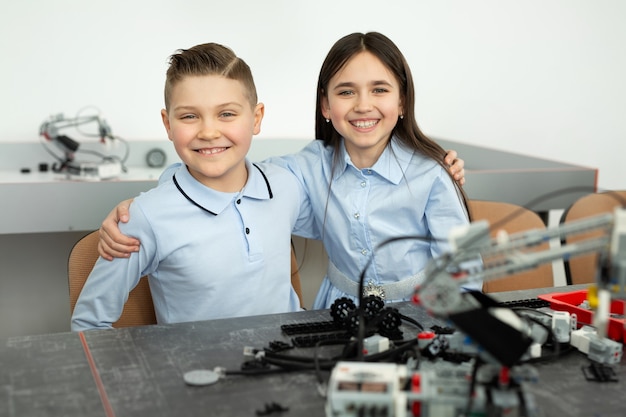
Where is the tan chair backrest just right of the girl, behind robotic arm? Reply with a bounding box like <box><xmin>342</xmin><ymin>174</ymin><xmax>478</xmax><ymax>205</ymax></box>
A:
<box><xmin>469</xmin><ymin>200</ymin><xmax>554</xmax><ymax>293</ymax></box>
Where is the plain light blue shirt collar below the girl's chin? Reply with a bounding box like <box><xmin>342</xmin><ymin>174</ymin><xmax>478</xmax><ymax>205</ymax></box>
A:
<box><xmin>334</xmin><ymin>136</ymin><xmax>414</xmax><ymax>184</ymax></box>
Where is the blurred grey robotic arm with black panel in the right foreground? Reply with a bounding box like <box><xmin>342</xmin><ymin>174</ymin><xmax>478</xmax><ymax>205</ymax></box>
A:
<box><xmin>415</xmin><ymin>208</ymin><xmax>626</xmax><ymax>365</ymax></box>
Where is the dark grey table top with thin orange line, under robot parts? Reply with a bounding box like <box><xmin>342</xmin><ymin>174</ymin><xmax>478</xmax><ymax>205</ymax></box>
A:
<box><xmin>0</xmin><ymin>289</ymin><xmax>626</xmax><ymax>417</ymax></box>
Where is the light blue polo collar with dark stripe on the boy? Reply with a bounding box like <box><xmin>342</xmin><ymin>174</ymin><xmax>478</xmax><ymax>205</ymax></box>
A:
<box><xmin>173</xmin><ymin>159</ymin><xmax>273</xmax><ymax>215</ymax></box>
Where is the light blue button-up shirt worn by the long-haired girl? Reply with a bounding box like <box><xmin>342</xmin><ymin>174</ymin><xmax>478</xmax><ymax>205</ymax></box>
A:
<box><xmin>271</xmin><ymin>139</ymin><xmax>472</xmax><ymax>308</ymax></box>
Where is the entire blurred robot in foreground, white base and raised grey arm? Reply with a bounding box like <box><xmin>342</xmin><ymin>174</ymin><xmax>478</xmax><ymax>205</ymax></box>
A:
<box><xmin>326</xmin><ymin>204</ymin><xmax>626</xmax><ymax>417</ymax></box>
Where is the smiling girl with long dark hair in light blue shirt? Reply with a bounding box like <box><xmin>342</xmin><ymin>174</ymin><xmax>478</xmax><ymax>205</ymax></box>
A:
<box><xmin>100</xmin><ymin>32</ymin><xmax>469</xmax><ymax>308</ymax></box>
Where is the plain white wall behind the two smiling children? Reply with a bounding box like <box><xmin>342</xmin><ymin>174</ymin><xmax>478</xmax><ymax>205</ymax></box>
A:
<box><xmin>0</xmin><ymin>0</ymin><xmax>626</xmax><ymax>188</ymax></box>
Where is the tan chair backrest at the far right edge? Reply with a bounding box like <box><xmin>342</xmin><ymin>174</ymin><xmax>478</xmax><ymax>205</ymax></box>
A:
<box><xmin>561</xmin><ymin>190</ymin><xmax>626</xmax><ymax>285</ymax></box>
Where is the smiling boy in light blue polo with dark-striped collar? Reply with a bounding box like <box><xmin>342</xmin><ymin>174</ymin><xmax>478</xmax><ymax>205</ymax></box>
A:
<box><xmin>71</xmin><ymin>43</ymin><xmax>309</xmax><ymax>331</ymax></box>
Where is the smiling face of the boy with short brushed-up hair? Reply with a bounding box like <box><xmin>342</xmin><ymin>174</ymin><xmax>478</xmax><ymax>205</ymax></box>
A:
<box><xmin>161</xmin><ymin>75</ymin><xmax>264</xmax><ymax>192</ymax></box>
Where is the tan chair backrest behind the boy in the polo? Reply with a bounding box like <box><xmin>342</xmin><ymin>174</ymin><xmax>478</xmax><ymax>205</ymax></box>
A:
<box><xmin>67</xmin><ymin>230</ymin><xmax>302</xmax><ymax>327</ymax></box>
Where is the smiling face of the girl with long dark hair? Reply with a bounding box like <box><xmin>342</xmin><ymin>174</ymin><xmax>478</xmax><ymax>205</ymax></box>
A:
<box><xmin>321</xmin><ymin>51</ymin><xmax>402</xmax><ymax>168</ymax></box>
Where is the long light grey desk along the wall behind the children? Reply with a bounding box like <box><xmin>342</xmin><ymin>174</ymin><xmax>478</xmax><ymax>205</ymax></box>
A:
<box><xmin>0</xmin><ymin>139</ymin><xmax>597</xmax><ymax>234</ymax></box>
